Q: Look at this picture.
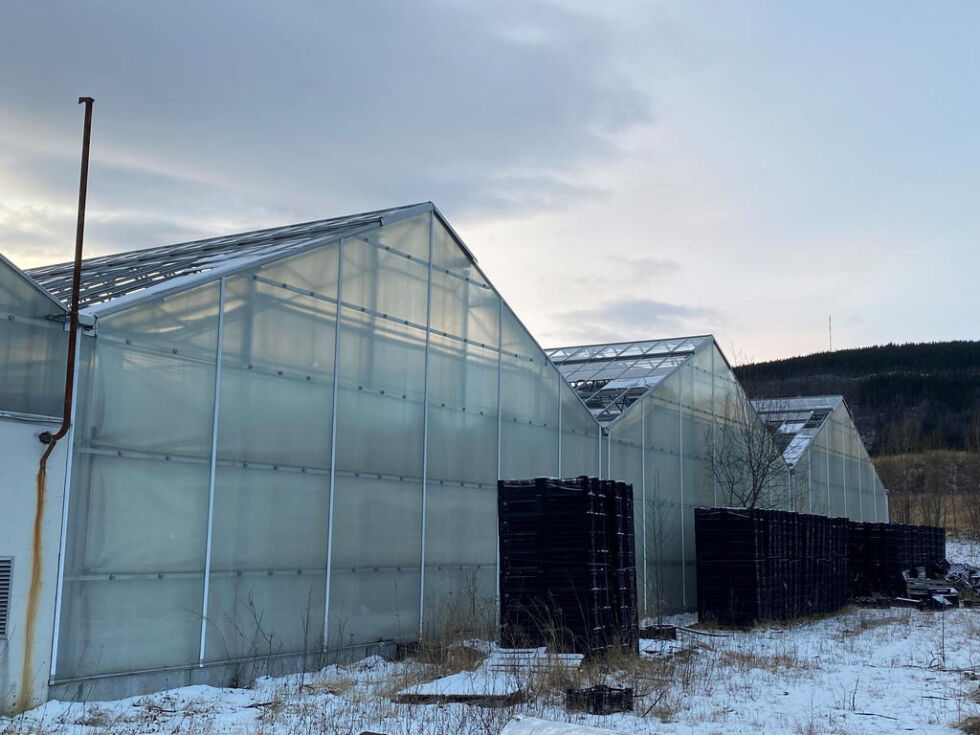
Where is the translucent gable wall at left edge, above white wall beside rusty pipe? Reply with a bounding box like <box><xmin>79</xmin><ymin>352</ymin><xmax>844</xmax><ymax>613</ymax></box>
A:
<box><xmin>0</xmin><ymin>258</ymin><xmax>68</xmax><ymax>416</ymax></box>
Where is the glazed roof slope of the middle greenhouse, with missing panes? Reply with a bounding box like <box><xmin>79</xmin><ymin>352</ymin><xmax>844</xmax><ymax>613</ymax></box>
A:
<box><xmin>545</xmin><ymin>334</ymin><xmax>714</xmax><ymax>426</ymax></box>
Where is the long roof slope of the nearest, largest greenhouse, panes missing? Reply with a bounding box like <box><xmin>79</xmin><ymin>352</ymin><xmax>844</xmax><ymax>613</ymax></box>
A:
<box><xmin>27</xmin><ymin>202</ymin><xmax>456</xmax><ymax>308</ymax></box>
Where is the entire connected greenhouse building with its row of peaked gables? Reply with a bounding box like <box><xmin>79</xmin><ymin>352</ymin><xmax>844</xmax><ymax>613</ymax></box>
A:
<box><xmin>0</xmin><ymin>203</ymin><xmax>886</xmax><ymax>710</ymax></box>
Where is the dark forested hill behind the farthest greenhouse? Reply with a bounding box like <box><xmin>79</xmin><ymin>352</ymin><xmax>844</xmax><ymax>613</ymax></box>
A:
<box><xmin>735</xmin><ymin>341</ymin><xmax>980</xmax><ymax>454</ymax></box>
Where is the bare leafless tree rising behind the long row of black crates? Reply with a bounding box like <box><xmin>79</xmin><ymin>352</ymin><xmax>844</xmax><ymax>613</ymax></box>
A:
<box><xmin>707</xmin><ymin>390</ymin><xmax>794</xmax><ymax>508</ymax></box>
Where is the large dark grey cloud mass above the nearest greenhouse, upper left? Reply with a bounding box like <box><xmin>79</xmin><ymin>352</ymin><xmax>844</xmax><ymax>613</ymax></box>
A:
<box><xmin>0</xmin><ymin>0</ymin><xmax>652</xmax><ymax>268</ymax></box>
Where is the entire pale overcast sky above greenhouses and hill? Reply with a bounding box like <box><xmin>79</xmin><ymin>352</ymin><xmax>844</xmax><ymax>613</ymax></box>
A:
<box><xmin>0</xmin><ymin>0</ymin><xmax>980</xmax><ymax>362</ymax></box>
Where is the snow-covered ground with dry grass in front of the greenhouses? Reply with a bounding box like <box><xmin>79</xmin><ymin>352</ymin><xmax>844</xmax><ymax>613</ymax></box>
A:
<box><xmin>0</xmin><ymin>542</ymin><xmax>980</xmax><ymax>735</ymax></box>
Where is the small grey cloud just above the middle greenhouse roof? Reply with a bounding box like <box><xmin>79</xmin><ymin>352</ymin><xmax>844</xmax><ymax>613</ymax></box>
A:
<box><xmin>553</xmin><ymin>298</ymin><xmax>725</xmax><ymax>343</ymax></box>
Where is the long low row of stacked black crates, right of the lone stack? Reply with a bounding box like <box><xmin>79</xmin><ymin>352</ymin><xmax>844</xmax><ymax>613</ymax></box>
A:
<box><xmin>694</xmin><ymin>508</ymin><xmax>946</xmax><ymax>626</ymax></box>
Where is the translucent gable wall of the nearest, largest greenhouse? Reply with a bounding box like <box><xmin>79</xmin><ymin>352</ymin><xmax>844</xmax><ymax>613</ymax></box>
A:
<box><xmin>53</xmin><ymin>212</ymin><xmax>598</xmax><ymax>681</ymax></box>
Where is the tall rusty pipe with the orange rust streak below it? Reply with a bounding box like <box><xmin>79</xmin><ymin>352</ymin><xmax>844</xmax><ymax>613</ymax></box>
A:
<box><xmin>17</xmin><ymin>97</ymin><xmax>95</xmax><ymax>711</ymax></box>
